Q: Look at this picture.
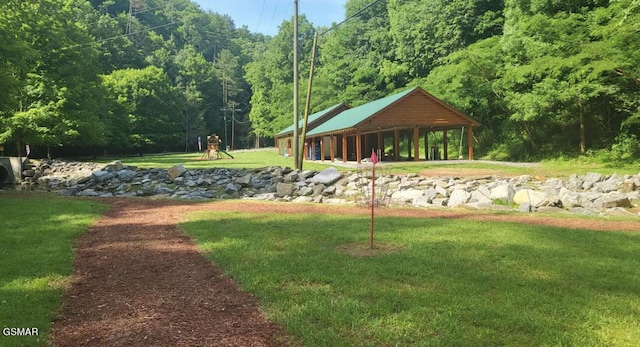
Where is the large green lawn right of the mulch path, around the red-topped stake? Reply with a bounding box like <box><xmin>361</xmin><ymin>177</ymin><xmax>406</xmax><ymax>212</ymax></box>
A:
<box><xmin>182</xmin><ymin>212</ymin><xmax>640</xmax><ymax>346</ymax></box>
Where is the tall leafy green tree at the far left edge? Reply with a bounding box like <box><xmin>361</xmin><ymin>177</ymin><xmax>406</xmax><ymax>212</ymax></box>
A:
<box><xmin>1</xmin><ymin>0</ymin><xmax>105</xmax><ymax>154</ymax></box>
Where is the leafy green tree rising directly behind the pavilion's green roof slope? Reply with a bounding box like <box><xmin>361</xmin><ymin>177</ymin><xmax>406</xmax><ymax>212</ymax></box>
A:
<box><xmin>313</xmin><ymin>0</ymin><xmax>398</xmax><ymax>108</ymax></box>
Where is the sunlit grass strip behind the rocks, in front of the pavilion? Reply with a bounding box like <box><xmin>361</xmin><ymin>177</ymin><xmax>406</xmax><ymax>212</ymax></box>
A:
<box><xmin>101</xmin><ymin>149</ymin><xmax>639</xmax><ymax>178</ymax></box>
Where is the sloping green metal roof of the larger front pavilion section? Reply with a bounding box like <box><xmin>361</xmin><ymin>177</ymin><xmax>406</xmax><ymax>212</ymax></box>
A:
<box><xmin>308</xmin><ymin>87</ymin><xmax>418</xmax><ymax>136</ymax></box>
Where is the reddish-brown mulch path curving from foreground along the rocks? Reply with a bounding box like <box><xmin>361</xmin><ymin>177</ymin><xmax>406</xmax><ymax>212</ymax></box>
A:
<box><xmin>49</xmin><ymin>198</ymin><xmax>640</xmax><ymax>346</ymax></box>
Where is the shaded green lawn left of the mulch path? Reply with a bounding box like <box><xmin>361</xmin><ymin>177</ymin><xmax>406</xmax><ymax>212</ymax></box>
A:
<box><xmin>0</xmin><ymin>192</ymin><xmax>105</xmax><ymax>346</ymax></box>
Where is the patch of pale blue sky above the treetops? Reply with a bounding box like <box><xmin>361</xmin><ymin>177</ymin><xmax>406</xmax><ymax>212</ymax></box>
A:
<box><xmin>191</xmin><ymin>0</ymin><xmax>346</xmax><ymax>36</ymax></box>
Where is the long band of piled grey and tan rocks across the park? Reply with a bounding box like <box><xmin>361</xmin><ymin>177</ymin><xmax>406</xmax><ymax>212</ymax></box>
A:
<box><xmin>23</xmin><ymin>161</ymin><xmax>640</xmax><ymax>216</ymax></box>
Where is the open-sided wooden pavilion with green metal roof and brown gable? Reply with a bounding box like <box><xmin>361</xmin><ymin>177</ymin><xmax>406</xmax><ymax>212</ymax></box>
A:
<box><xmin>276</xmin><ymin>87</ymin><xmax>480</xmax><ymax>163</ymax></box>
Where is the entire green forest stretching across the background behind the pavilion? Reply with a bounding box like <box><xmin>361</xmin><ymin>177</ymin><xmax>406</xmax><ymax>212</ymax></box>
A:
<box><xmin>0</xmin><ymin>0</ymin><xmax>640</xmax><ymax>160</ymax></box>
